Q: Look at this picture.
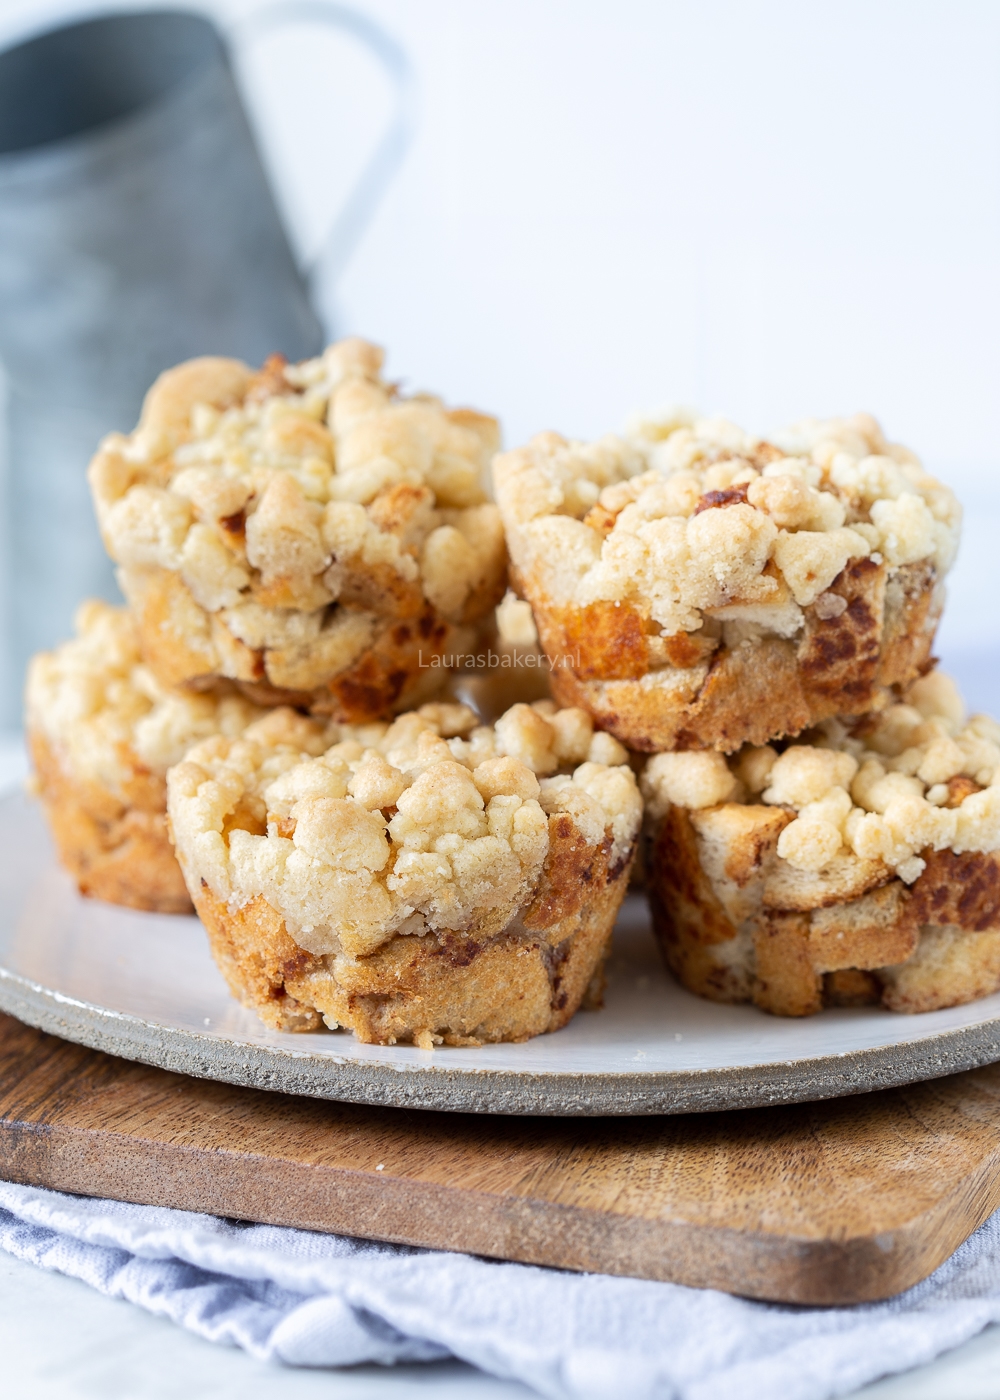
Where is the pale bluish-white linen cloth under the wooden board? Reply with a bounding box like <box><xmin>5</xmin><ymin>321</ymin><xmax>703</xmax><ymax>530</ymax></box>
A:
<box><xmin>0</xmin><ymin>1182</ymin><xmax>1000</xmax><ymax>1400</ymax></box>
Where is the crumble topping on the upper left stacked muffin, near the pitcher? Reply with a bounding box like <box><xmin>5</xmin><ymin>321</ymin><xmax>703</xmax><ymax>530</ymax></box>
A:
<box><xmin>90</xmin><ymin>339</ymin><xmax>506</xmax><ymax>666</ymax></box>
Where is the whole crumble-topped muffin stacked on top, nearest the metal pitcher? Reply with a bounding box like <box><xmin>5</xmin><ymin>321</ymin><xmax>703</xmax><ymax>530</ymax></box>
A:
<box><xmin>90</xmin><ymin>340</ymin><xmax>506</xmax><ymax>721</ymax></box>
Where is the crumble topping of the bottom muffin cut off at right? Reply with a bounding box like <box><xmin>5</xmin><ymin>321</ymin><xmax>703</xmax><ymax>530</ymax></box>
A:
<box><xmin>641</xmin><ymin>671</ymin><xmax>1000</xmax><ymax>883</ymax></box>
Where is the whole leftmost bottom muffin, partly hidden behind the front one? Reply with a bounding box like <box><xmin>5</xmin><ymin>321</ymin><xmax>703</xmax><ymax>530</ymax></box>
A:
<box><xmin>25</xmin><ymin>602</ymin><xmax>265</xmax><ymax>914</ymax></box>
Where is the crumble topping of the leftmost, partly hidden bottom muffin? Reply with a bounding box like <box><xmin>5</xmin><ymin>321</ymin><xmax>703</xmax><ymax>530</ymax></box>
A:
<box><xmin>25</xmin><ymin>601</ymin><xmax>263</xmax><ymax>794</ymax></box>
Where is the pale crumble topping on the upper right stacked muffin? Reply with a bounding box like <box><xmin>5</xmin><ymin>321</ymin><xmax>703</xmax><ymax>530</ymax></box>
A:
<box><xmin>494</xmin><ymin>412</ymin><xmax>961</xmax><ymax>637</ymax></box>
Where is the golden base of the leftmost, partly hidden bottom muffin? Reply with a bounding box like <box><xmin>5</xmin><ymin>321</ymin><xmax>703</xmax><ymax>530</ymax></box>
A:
<box><xmin>28</xmin><ymin>731</ymin><xmax>192</xmax><ymax>914</ymax></box>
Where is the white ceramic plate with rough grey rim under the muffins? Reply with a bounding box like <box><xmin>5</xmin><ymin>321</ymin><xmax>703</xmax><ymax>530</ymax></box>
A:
<box><xmin>0</xmin><ymin>794</ymin><xmax>1000</xmax><ymax>1114</ymax></box>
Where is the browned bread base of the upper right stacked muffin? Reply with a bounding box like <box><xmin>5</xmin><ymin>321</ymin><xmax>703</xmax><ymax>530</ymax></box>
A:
<box><xmin>526</xmin><ymin>559</ymin><xmax>944</xmax><ymax>753</ymax></box>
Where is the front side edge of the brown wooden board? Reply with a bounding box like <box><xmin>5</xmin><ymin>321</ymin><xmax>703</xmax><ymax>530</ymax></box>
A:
<box><xmin>0</xmin><ymin>1119</ymin><xmax>1000</xmax><ymax>1306</ymax></box>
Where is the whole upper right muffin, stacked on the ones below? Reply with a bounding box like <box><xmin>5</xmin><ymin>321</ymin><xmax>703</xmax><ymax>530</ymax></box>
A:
<box><xmin>494</xmin><ymin>414</ymin><xmax>959</xmax><ymax>753</ymax></box>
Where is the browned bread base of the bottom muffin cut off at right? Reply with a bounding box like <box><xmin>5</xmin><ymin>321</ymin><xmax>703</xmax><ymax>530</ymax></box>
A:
<box><xmin>647</xmin><ymin>808</ymin><xmax>1000</xmax><ymax>1016</ymax></box>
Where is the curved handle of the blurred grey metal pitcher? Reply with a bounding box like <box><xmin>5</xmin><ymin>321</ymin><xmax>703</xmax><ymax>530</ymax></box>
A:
<box><xmin>230</xmin><ymin>0</ymin><xmax>415</xmax><ymax>292</ymax></box>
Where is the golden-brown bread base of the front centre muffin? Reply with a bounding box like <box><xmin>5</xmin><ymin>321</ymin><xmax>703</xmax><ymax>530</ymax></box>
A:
<box><xmin>192</xmin><ymin>813</ymin><xmax>632</xmax><ymax>1050</ymax></box>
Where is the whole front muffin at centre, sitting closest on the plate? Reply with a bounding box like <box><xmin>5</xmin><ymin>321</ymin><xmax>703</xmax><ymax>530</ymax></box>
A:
<box><xmin>168</xmin><ymin>701</ymin><xmax>641</xmax><ymax>1049</ymax></box>
